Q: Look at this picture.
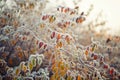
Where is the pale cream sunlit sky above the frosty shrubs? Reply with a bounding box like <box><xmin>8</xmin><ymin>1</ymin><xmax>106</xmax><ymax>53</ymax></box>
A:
<box><xmin>46</xmin><ymin>0</ymin><xmax>120</xmax><ymax>35</ymax></box>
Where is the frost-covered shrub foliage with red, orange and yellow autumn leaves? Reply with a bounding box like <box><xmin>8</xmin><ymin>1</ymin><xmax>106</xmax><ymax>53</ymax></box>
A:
<box><xmin>0</xmin><ymin>0</ymin><xmax>120</xmax><ymax>80</ymax></box>
